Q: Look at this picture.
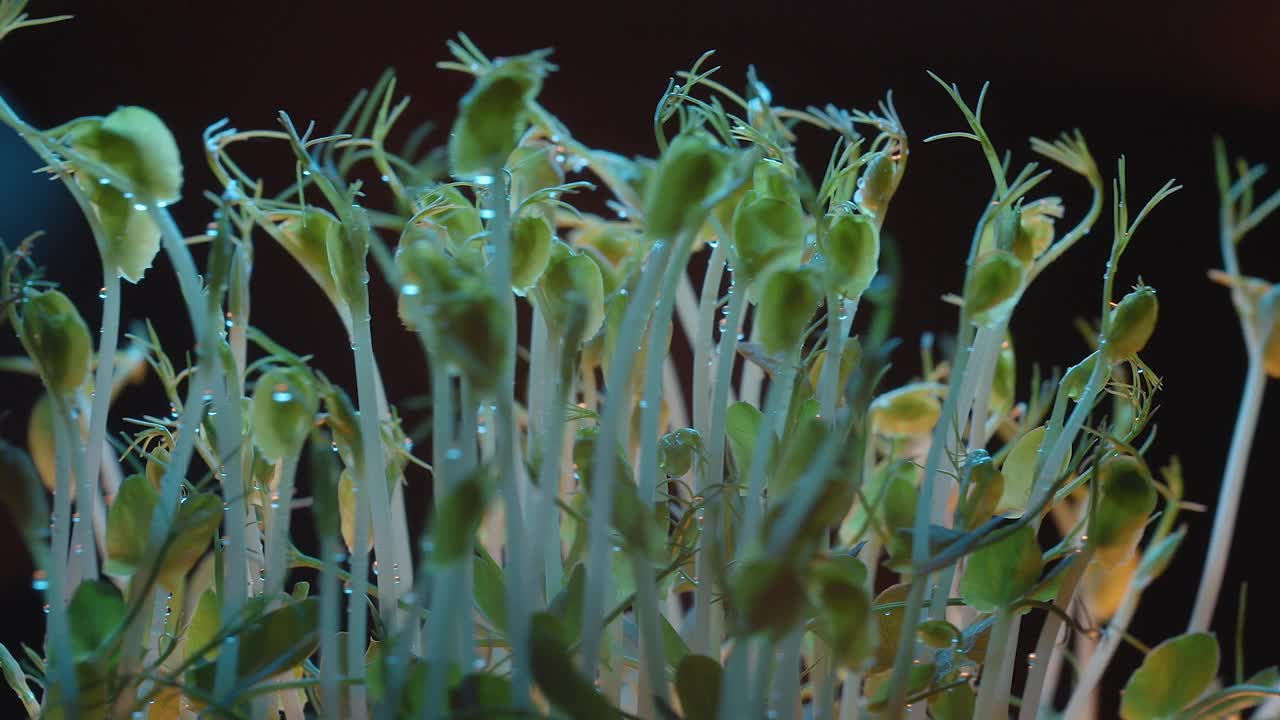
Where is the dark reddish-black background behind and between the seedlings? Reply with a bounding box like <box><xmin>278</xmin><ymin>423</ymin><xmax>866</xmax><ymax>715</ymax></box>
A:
<box><xmin>0</xmin><ymin>0</ymin><xmax>1280</xmax><ymax>715</ymax></box>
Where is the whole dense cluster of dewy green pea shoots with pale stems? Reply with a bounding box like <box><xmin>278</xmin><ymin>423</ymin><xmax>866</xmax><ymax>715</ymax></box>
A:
<box><xmin>0</xmin><ymin>0</ymin><xmax>1280</xmax><ymax>720</ymax></box>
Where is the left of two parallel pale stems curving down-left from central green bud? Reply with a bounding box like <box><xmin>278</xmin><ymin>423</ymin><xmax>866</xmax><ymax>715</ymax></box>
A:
<box><xmin>581</xmin><ymin>233</ymin><xmax>691</xmax><ymax>680</ymax></box>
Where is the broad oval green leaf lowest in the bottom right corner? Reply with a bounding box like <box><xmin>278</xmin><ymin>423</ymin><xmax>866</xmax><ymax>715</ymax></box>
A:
<box><xmin>1120</xmin><ymin>633</ymin><xmax>1219</xmax><ymax>720</ymax></box>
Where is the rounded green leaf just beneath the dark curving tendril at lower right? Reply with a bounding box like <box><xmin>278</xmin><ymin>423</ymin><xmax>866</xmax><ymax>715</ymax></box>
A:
<box><xmin>960</xmin><ymin>525</ymin><xmax>1041</xmax><ymax>612</ymax></box>
